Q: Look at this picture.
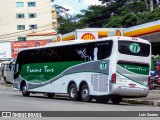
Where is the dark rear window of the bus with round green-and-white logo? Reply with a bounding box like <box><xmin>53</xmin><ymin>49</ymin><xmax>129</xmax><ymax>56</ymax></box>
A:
<box><xmin>118</xmin><ymin>40</ymin><xmax>150</xmax><ymax>57</ymax></box>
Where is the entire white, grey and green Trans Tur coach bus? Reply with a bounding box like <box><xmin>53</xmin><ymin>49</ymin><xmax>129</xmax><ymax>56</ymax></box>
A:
<box><xmin>14</xmin><ymin>36</ymin><xmax>151</xmax><ymax>104</ymax></box>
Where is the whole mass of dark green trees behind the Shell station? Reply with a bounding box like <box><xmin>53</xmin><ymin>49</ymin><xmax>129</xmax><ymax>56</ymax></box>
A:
<box><xmin>58</xmin><ymin>0</ymin><xmax>160</xmax><ymax>34</ymax></box>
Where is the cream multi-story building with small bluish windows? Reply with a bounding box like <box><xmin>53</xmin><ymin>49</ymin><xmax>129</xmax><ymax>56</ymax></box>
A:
<box><xmin>0</xmin><ymin>0</ymin><xmax>56</xmax><ymax>41</ymax></box>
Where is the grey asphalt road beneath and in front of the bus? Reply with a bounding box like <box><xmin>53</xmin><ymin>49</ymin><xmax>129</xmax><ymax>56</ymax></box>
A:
<box><xmin>0</xmin><ymin>81</ymin><xmax>160</xmax><ymax>120</ymax></box>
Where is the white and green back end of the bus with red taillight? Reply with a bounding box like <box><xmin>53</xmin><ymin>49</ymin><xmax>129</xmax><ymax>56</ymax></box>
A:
<box><xmin>110</xmin><ymin>37</ymin><xmax>151</xmax><ymax>102</ymax></box>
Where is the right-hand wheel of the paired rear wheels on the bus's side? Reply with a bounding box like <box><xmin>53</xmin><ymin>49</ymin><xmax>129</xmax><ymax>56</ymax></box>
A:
<box><xmin>81</xmin><ymin>84</ymin><xmax>92</xmax><ymax>102</ymax></box>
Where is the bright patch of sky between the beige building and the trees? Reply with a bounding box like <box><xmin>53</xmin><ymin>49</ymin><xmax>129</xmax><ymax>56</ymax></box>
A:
<box><xmin>54</xmin><ymin>0</ymin><xmax>102</xmax><ymax>15</ymax></box>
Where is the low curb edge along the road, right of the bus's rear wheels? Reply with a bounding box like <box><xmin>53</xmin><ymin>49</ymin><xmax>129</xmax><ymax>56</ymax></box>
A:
<box><xmin>123</xmin><ymin>99</ymin><xmax>160</xmax><ymax>107</ymax></box>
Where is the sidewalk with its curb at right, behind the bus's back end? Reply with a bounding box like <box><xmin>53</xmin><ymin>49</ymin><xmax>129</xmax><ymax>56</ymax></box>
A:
<box><xmin>123</xmin><ymin>90</ymin><xmax>160</xmax><ymax>107</ymax></box>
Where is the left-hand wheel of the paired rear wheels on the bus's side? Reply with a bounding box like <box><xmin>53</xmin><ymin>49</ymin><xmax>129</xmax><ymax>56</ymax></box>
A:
<box><xmin>68</xmin><ymin>84</ymin><xmax>80</xmax><ymax>101</ymax></box>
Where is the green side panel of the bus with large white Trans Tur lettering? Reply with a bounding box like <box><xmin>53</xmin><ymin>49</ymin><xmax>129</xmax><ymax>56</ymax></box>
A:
<box><xmin>20</xmin><ymin>61</ymin><xmax>84</xmax><ymax>83</ymax></box>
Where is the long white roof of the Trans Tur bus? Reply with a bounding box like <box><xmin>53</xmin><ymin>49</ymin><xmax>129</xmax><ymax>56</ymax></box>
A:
<box><xmin>20</xmin><ymin>36</ymin><xmax>150</xmax><ymax>52</ymax></box>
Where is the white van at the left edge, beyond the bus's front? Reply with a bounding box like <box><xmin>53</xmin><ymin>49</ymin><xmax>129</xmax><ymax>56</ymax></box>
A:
<box><xmin>1</xmin><ymin>61</ymin><xmax>14</xmax><ymax>83</ymax></box>
